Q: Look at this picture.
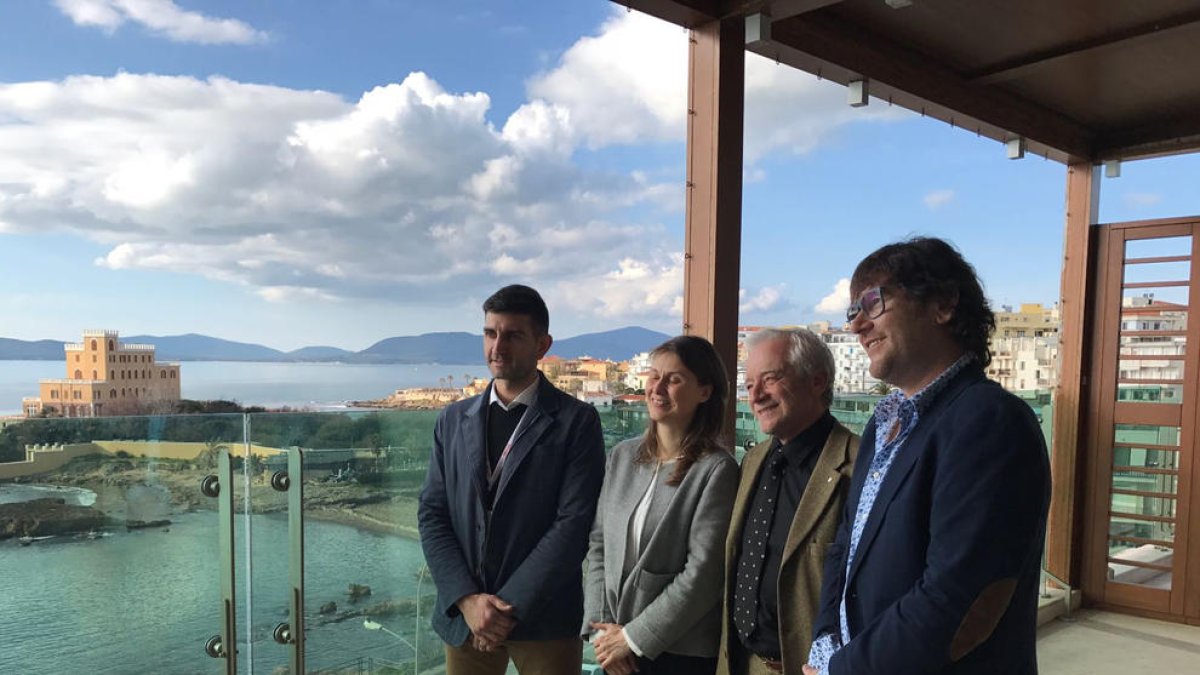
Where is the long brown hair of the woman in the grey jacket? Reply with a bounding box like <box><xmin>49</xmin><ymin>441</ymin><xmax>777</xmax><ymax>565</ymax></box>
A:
<box><xmin>637</xmin><ymin>335</ymin><xmax>730</xmax><ymax>485</ymax></box>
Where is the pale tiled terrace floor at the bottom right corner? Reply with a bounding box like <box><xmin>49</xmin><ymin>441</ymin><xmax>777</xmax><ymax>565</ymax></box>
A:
<box><xmin>1038</xmin><ymin>610</ymin><xmax>1200</xmax><ymax>675</ymax></box>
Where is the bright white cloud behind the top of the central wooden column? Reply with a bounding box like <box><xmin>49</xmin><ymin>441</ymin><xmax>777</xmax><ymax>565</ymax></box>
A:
<box><xmin>528</xmin><ymin>10</ymin><xmax>908</xmax><ymax>165</ymax></box>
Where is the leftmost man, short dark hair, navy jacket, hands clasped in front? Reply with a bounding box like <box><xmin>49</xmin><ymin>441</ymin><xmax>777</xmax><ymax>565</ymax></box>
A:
<box><xmin>418</xmin><ymin>286</ymin><xmax>605</xmax><ymax>675</ymax></box>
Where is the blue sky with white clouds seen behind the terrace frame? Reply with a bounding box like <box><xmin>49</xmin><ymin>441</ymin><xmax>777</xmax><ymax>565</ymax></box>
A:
<box><xmin>0</xmin><ymin>0</ymin><xmax>1200</xmax><ymax>350</ymax></box>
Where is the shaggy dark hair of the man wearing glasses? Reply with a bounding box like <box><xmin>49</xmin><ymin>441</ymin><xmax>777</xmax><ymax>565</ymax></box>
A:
<box><xmin>850</xmin><ymin>237</ymin><xmax>996</xmax><ymax>368</ymax></box>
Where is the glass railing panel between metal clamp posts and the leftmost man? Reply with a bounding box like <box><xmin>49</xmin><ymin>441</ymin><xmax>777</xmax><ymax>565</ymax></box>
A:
<box><xmin>250</xmin><ymin>411</ymin><xmax>444</xmax><ymax>673</ymax></box>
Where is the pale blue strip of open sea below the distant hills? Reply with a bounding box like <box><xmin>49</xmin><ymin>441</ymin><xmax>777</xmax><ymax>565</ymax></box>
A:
<box><xmin>0</xmin><ymin>360</ymin><xmax>488</xmax><ymax>416</ymax></box>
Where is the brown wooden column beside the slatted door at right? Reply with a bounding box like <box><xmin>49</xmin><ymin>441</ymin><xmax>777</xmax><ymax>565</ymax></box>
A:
<box><xmin>1046</xmin><ymin>161</ymin><xmax>1100</xmax><ymax>589</ymax></box>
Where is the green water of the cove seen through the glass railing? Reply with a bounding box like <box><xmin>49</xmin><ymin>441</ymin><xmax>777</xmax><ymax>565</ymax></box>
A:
<box><xmin>0</xmin><ymin>513</ymin><xmax>440</xmax><ymax>675</ymax></box>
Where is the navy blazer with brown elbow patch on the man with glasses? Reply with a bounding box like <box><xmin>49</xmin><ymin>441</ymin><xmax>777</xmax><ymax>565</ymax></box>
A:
<box><xmin>814</xmin><ymin>366</ymin><xmax>1050</xmax><ymax>675</ymax></box>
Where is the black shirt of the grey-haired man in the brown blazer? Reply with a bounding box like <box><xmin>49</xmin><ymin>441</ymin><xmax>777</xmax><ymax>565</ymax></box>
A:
<box><xmin>738</xmin><ymin>411</ymin><xmax>834</xmax><ymax>659</ymax></box>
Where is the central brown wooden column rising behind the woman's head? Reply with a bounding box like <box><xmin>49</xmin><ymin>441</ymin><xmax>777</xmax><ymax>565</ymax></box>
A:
<box><xmin>683</xmin><ymin>17</ymin><xmax>745</xmax><ymax>401</ymax></box>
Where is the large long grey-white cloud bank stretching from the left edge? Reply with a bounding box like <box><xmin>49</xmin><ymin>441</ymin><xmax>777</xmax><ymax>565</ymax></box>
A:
<box><xmin>0</xmin><ymin>73</ymin><xmax>683</xmax><ymax>318</ymax></box>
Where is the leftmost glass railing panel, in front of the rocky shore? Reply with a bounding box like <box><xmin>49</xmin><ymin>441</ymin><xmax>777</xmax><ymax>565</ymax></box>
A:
<box><xmin>0</xmin><ymin>414</ymin><xmax>244</xmax><ymax>674</ymax></box>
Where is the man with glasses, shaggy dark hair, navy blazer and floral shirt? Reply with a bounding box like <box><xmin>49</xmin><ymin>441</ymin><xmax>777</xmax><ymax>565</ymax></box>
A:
<box><xmin>804</xmin><ymin>238</ymin><xmax>1050</xmax><ymax>675</ymax></box>
